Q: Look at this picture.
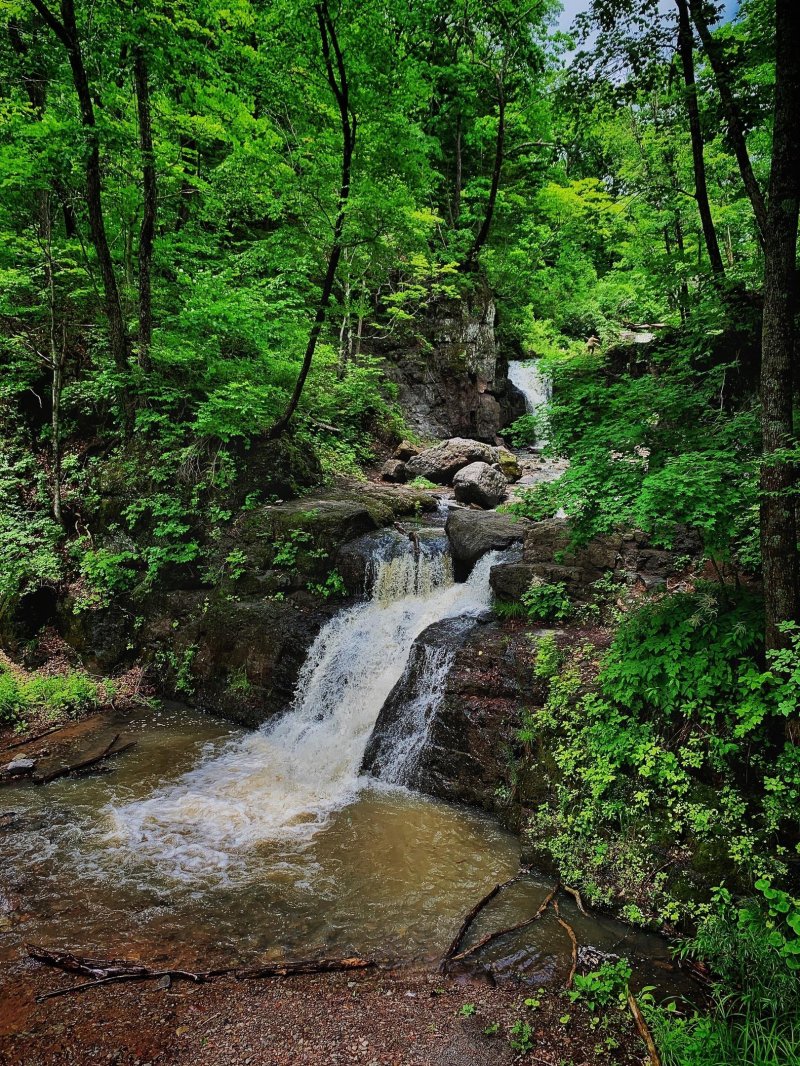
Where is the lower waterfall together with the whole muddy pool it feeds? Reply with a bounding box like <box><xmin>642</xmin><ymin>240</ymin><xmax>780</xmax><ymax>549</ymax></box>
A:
<box><xmin>0</xmin><ymin>534</ymin><xmax>691</xmax><ymax>984</ymax></box>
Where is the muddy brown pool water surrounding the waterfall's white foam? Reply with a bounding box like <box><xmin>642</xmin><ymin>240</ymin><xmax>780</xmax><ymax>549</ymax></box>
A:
<box><xmin>0</xmin><ymin>707</ymin><xmax>682</xmax><ymax>991</ymax></box>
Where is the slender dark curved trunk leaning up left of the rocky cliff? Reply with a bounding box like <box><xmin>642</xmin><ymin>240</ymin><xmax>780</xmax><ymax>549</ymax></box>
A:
<box><xmin>267</xmin><ymin>0</ymin><xmax>356</xmax><ymax>440</ymax></box>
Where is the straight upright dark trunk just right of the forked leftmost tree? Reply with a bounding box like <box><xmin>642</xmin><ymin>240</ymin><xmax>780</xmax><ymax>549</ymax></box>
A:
<box><xmin>133</xmin><ymin>44</ymin><xmax>158</xmax><ymax>370</ymax></box>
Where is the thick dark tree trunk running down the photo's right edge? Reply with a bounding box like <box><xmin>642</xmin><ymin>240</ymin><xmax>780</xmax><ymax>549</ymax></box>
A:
<box><xmin>761</xmin><ymin>0</ymin><xmax>800</xmax><ymax>649</ymax></box>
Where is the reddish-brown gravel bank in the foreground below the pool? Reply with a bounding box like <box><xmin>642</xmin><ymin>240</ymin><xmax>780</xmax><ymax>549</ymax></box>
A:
<box><xmin>0</xmin><ymin>959</ymin><xmax>645</xmax><ymax>1066</ymax></box>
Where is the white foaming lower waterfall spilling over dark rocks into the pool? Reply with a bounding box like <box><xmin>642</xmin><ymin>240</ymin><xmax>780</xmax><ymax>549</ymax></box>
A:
<box><xmin>111</xmin><ymin>543</ymin><xmax>498</xmax><ymax>879</ymax></box>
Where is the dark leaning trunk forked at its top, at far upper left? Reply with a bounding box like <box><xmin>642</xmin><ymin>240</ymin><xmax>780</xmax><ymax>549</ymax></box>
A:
<box><xmin>31</xmin><ymin>0</ymin><xmax>129</xmax><ymax>371</ymax></box>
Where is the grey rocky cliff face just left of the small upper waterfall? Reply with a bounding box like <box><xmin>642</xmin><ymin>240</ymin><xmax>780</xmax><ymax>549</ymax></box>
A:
<box><xmin>365</xmin><ymin>289</ymin><xmax>525</xmax><ymax>442</ymax></box>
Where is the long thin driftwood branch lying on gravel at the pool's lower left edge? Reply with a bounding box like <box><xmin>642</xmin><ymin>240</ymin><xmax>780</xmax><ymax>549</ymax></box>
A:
<box><xmin>28</xmin><ymin>944</ymin><xmax>375</xmax><ymax>1003</ymax></box>
